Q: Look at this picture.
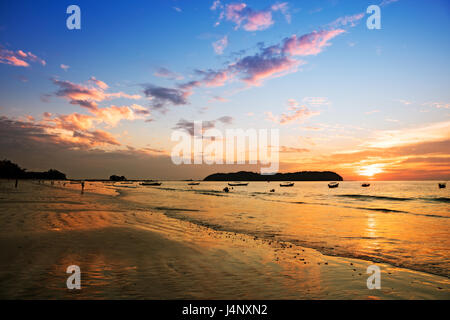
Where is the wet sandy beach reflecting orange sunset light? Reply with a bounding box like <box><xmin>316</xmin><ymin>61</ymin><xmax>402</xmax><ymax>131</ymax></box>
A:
<box><xmin>0</xmin><ymin>181</ymin><xmax>450</xmax><ymax>299</ymax></box>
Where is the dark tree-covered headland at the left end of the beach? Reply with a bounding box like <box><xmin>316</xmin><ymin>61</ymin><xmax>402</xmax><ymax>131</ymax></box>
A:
<box><xmin>0</xmin><ymin>160</ymin><xmax>66</xmax><ymax>180</ymax></box>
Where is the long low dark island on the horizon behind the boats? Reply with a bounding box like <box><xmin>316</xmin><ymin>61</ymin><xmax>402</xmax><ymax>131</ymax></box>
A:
<box><xmin>203</xmin><ymin>171</ymin><xmax>344</xmax><ymax>181</ymax></box>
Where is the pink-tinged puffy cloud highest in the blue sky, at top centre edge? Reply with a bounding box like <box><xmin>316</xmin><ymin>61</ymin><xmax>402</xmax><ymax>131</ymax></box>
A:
<box><xmin>211</xmin><ymin>1</ymin><xmax>291</xmax><ymax>31</ymax></box>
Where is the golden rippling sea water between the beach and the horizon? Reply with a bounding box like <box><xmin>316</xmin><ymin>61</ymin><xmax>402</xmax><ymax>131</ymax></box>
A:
<box><xmin>107</xmin><ymin>181</ymin><xmax>450</xmax><ymax>277</ymax></box>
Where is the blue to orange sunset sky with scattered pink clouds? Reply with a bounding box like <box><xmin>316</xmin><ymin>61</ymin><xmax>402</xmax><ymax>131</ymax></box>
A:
<box><xmin>0</xmin><ymin>0</ymin><xmax>450</xmax><ymax>180</ymax></box>
